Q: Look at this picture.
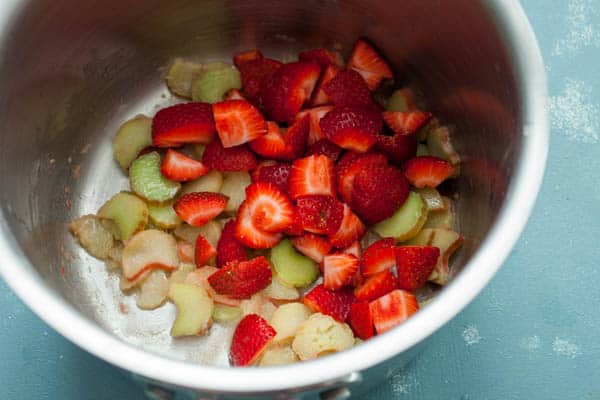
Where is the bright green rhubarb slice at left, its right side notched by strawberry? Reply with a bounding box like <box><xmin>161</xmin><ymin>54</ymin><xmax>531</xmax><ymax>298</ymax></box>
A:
<box><xmin>129</xmin><ymin>151</ymin><xmax>181</xmax><ymax>203</ymax></box>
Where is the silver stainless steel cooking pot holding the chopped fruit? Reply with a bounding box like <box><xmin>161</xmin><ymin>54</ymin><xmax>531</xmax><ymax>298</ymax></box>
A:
<box><xmin>0</xmin><ymin>0</ymin><xmax>548</xmax><ymax>397</ymax></box>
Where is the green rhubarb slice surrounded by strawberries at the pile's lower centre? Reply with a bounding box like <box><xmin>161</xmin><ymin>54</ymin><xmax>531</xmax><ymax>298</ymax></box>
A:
<box><xmin>271</xmin><ymin>239</ymin><xmax>319</xmax><ymax>287</ymax></box>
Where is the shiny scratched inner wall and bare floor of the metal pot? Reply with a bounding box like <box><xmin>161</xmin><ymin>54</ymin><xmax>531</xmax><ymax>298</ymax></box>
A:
<box><xmin>0</xmin><ymin>0</ymin><xmax>521</xmax><ymax>364</ymax></box>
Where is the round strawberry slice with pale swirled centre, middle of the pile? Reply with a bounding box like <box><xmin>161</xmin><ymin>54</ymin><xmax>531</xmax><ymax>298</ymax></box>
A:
<box><xmin>246</xmin><ymin>182</ymin><xmax>295</xmax><ymax>232</ymax></box>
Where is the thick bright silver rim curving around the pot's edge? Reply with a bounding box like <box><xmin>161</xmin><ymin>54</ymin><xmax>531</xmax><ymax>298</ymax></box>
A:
<box><xmin>0</xmin><ymin>0</ymin><xmax>549</xmax><ymax>394</ymax></box>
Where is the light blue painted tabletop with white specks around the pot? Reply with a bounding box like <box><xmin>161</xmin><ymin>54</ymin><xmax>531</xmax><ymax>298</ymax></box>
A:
<box><xmin>0</xmin><ymin>0</ymin><xmax>600</xmax><ymax>400</ymax></box>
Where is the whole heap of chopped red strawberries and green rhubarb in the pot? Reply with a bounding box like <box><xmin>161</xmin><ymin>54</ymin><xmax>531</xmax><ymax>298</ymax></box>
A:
<box><xmin>70</xmin><ymin>39</ymin><xmax>462</xmax><ymax>366</ymax></box>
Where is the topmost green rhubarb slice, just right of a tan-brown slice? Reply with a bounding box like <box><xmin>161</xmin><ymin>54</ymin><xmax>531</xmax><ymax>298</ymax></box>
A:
<box><xmin>192</xmin><ymin>63</ymin><xmax>242</xmax><ymax>103</ymax></box>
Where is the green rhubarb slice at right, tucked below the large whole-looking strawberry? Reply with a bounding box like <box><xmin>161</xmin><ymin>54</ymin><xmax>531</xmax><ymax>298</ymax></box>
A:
<box><xmin>373</xmin><ymin>192</ymin><xmax>427</xmax><ymax>242</ymax></box>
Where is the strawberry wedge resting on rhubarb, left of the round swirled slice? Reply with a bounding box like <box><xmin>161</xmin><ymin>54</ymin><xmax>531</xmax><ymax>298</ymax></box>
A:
<box><xmin>173</xmin><ymin>192</ymin><xmax>229</xmax><ymax>226</ymax></box>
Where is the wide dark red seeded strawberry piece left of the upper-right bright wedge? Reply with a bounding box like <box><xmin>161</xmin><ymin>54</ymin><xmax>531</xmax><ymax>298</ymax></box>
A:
<box><xmin>319</xmin><ymin>106</ymin><xmax>383</xmax><ymax>153</ymax></box>
